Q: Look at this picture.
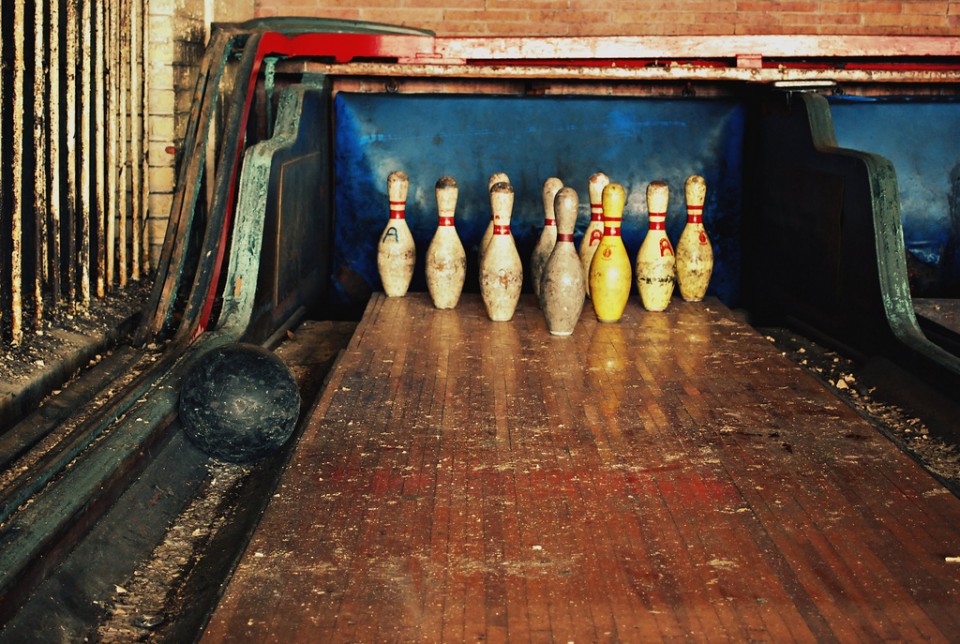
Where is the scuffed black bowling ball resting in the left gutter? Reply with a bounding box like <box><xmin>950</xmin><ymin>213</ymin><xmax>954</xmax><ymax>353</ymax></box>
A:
<box><xmin>179</xmin><ymin>343</ymin><xmax>300</xmax><ymax>463</ymax></box>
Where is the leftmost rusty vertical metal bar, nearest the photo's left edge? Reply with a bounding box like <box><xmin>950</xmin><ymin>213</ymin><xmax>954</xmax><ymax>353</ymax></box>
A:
<box><xmin>10</xmin><ymin>2</ymin><xmax>26</xmax><ymax>345</ymax></box>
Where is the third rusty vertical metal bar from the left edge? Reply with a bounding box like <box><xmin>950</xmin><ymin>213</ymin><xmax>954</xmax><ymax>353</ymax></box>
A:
<box><xmin>49</xmin><ymin>0</ymin><xmax>61</xmax><ymax>307</ymax></box>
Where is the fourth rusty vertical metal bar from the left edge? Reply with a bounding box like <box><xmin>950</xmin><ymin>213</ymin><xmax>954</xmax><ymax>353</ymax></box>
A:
<box><xmin>65</xmin><ymin>0</ymin><xmax>80</xmax><ymax>308</ymax></box>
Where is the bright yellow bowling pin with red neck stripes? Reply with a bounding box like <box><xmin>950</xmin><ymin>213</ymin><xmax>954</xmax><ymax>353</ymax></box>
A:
<box><xmin>588</xmin><ymin>183</ymin><xmax>632</xmax><ymax>322</ymax></box>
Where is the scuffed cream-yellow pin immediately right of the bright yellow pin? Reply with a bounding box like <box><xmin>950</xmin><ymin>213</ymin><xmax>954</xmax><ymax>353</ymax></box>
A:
<box><xmin>637</xmin><ymin>181</ymin><xmax>676</xmax><ymax>311</ymax></box>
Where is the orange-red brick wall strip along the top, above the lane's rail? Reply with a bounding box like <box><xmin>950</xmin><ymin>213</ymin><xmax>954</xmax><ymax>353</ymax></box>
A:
<box><xmin>255</xmin><ymin>0</ymin><xmax>960</xmax><ymax>36</ymax></box>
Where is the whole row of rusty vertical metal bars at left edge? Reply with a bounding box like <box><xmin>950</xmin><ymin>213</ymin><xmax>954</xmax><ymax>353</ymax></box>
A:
<box><xmin>0</xmin><ymin>0</ymin><xmax>148</xmax><ymax>347</ymax></box>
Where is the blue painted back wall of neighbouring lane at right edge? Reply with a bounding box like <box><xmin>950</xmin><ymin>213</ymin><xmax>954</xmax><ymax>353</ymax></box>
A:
<box><xmin>831</xmin><ymin>97</ymin><xmax>960</xmax><ymax>296</ymax></box>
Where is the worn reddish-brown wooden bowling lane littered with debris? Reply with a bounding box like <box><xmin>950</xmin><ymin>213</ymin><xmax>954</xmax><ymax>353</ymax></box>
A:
<box><xmin>204</xmin><ymin>294</ymin><xmax>960</xmax><ymax>642</ymax></box>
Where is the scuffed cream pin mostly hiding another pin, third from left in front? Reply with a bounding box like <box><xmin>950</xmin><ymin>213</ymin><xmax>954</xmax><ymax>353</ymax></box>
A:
<box><xmin>480</xmin><ymin>182</ymin><xmax>523</xmax><ymax>322</ymax></box>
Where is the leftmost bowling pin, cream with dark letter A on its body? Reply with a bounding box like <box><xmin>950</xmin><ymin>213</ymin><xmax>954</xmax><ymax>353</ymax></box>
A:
<box><xmin>377</xmin><ymin>170</ymin><xmax>417</xmax><ymax>297</ymax></box>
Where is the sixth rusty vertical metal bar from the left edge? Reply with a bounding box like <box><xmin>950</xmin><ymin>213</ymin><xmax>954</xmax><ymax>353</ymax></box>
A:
<box><xmin>93</xmin><ymin>1</ymin><xmax>107</xmax><ymax>298</ymax></box>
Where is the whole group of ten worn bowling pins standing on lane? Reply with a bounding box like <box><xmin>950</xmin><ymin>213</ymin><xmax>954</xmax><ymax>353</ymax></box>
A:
<box><xmin>377</xmin><ymin>172</ymin><xmax>713</xmax><ymax>335</ymax></box>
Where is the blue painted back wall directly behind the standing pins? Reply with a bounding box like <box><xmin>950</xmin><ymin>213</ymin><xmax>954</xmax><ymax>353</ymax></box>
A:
<box><xmin>332</xmin><ymin>93</ymin><xmax>745</xmax><ymax>306</ymax></box>
